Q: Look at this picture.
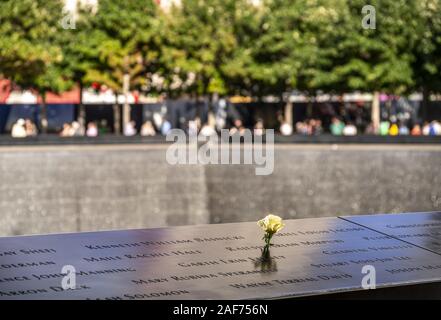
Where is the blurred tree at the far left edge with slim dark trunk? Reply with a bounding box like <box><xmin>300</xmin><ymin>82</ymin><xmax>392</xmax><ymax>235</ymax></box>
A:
<box><xmin>0</xmin><ymin>0</ymin><xmax>72</xmax><ymax>132</ymax></box>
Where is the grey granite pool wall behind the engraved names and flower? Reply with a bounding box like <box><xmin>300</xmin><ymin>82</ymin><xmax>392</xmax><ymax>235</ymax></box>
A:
<box><xmin>0</xmin><ymin>144</ymin><xmax>441</xmax><ymax>236</ymax></box>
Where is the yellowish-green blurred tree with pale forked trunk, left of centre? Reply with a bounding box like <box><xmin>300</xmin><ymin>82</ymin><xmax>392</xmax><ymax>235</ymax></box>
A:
<box><xmin>79</xmin><ymin>0</ymin><xmax>161</xmax><ymax>132</ymax></box>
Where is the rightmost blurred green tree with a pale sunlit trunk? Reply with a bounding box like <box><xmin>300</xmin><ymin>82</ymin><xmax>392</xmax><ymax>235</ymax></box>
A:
<box><xmin>311</xmin><ymin>0</ymin><xmax>419</xmax><ymax>130</ymax></box>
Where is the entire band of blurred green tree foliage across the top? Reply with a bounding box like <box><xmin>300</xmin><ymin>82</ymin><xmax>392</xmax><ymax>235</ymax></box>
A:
<box><xmin>0</xmin><ymin>0</ymin><xmax>441</xmax><ymax>96</ymax></box>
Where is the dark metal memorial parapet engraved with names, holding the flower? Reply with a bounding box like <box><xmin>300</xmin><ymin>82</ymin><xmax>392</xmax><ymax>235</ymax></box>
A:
<box><xmin>0</xmin><ymin>213</ymin><xmax>441</xmax><ymax>299</ymax></box>
